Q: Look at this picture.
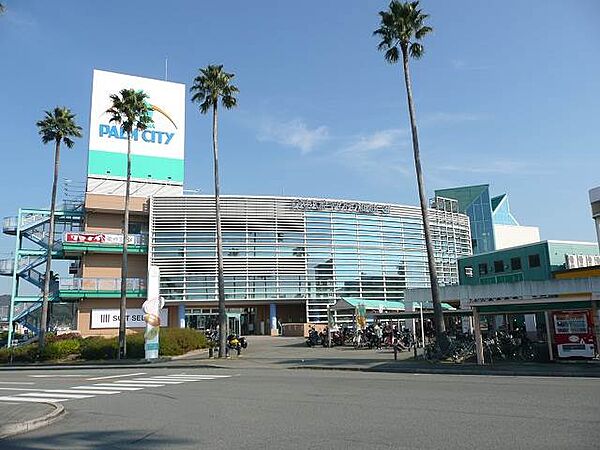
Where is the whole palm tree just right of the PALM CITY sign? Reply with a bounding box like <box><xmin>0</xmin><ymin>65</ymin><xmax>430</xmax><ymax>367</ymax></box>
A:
<box><xmin>190</xmin><ymin>65</ymin><xmax>239</xmax><ymax>358</ymax></box>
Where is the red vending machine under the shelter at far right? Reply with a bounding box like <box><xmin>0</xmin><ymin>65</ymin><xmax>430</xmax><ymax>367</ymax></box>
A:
<box><xmin>552</xmin><ymin>311</ymin><xmax>595</xmax><ymax>358</ymax></box>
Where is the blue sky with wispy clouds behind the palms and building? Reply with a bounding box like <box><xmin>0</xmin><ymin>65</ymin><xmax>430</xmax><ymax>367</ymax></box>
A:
<box><xmin>0</xmin><ymin>0</ymin><xmax>600</xmax><ymax>264</ymax></box>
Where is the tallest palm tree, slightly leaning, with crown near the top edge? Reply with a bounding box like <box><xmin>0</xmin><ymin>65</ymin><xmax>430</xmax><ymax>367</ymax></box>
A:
<box><xmin>373</xmin><ymin>0</ymin><xmax>448</xmax><ymax>350</ymax></box>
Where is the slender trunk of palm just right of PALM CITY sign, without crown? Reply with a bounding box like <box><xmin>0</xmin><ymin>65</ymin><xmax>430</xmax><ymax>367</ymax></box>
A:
<box><xmin>213</xmin><ymin>103</ymin><xmax>227</xmax><ymax>358</ymax></box>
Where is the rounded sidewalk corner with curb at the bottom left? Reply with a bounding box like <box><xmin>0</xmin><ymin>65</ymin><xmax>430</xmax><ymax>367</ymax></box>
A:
<box><xmin>0</xmin><ymin>402</ymin><xmax>65</xmax><ymax>439</ymax></box>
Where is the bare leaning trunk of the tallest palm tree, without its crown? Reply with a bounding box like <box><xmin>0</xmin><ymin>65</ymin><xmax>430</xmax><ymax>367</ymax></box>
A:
<box><xmin>402</xmin><ymin>47</ymin><xmax>448</xmax><ymax>349</ymax></box>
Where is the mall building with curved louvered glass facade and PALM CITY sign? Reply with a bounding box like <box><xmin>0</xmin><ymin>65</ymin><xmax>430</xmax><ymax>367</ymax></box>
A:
<box><xmin>0</xmin><ymin>71</ymin><xmax>472</xmax><ymax>342</ymax></box>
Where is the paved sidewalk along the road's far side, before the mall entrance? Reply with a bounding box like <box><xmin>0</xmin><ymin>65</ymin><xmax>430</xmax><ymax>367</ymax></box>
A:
<box><xmin>0</xmin><ymin>336</ymin><xmax>600</xmax><ymax>378</ymax></box>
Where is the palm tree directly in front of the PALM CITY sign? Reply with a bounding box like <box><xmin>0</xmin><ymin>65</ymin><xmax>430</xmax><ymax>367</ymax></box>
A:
<box><xmin>106</xmin><ymin>89</ymin><xmax>153</xmax><ymax>359</ymax></box>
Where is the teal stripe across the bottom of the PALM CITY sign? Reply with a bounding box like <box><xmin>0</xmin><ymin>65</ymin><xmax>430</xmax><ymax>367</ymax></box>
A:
<box><xmin>88</xmin><ymin>150</ymin><xmax>183</xmax><ymax>183</ymax></box>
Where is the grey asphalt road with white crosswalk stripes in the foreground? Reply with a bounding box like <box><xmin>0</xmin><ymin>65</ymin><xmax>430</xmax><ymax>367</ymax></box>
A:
<box><xmin>0</xmin><ymin>339</ymin><xmax>600</xmax><ymax>449</ymax></box>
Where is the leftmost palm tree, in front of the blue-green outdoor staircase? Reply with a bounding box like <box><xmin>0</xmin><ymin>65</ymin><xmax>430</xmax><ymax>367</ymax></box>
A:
<box><xmin>36</xmin><ymin>107</ymin><xmax>82</xmax><ymax>353</ymax></box>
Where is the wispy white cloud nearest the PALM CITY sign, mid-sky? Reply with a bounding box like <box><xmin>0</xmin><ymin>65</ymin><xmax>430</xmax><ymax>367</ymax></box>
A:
<box><xmin>258</xmin><ymin>119</ymin><xmax>329</xmax><ymax>153</ymax></box>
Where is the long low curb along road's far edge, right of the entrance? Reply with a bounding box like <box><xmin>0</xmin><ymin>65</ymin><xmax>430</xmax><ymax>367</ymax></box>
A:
<box><xmin>288</xmin><ymin>366</ymin><xmax>600</xmax><ymax>378</ymax></box>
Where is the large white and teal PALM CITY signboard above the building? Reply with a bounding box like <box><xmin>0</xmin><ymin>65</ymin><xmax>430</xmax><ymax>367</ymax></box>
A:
<box><xmin>88</xmin><ymin>70</ymin><xmax>185</xmax><ymax>184</ymax></box>
